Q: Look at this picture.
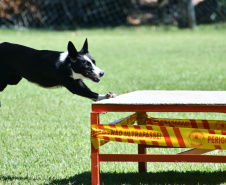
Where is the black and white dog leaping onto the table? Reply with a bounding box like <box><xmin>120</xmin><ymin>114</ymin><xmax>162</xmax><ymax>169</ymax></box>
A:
<box><xmin>0</xmin><ymin>39</ymin><xmax>116</xmax><ymax>101</ymax></box>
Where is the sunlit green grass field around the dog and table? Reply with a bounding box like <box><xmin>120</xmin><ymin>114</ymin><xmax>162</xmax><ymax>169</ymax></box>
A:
<box><xmin>0</xmin><ymin>25</ymin><xmax>226</xmax><ymax>185</ymax></box>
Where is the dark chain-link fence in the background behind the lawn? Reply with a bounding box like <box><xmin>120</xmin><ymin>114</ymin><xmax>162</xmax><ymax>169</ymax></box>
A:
<box><xmin>0</xmin><ymin>0</ymin><xmax>226</xmax><ymax>29</ymax></box>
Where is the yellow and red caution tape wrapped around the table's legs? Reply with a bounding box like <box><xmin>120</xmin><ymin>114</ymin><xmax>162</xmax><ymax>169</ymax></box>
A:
<box><xmin>91</xmin><ymin>114</ymin><xmax>226</xmax><ymax>150</ymax></box>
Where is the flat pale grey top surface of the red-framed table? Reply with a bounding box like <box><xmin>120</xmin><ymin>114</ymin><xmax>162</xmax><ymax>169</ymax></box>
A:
<box><xmin>93</xmin><ymin>91</ymin><xmax>226</xmax><ymax>105</ymax></box>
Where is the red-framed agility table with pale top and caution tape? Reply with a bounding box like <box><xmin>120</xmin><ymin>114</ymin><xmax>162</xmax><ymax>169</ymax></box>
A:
<box><xmin>91</xmin><ymin>91</ymin><xmax>226</xmax><ymax>185</ymax></box>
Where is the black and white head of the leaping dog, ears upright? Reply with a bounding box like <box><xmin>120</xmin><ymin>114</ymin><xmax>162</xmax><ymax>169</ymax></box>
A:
<box><xmin>64</xmin><ymin>39</ymin><xmax>104</xmax><ymax>82</ymax></box>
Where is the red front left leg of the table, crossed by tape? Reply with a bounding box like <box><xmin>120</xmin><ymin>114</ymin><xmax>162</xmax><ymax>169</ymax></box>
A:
<box><xmin>91</xmin><ymin>112</ymin><xmax>100</xmax><ymax>185</ymax></box>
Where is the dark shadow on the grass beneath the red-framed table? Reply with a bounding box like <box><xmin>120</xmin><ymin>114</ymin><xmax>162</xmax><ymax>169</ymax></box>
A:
<box><xmin>50</xmin><ymin>171</ymin><xmax>226</xmax><ymax>185</ymax></box>
